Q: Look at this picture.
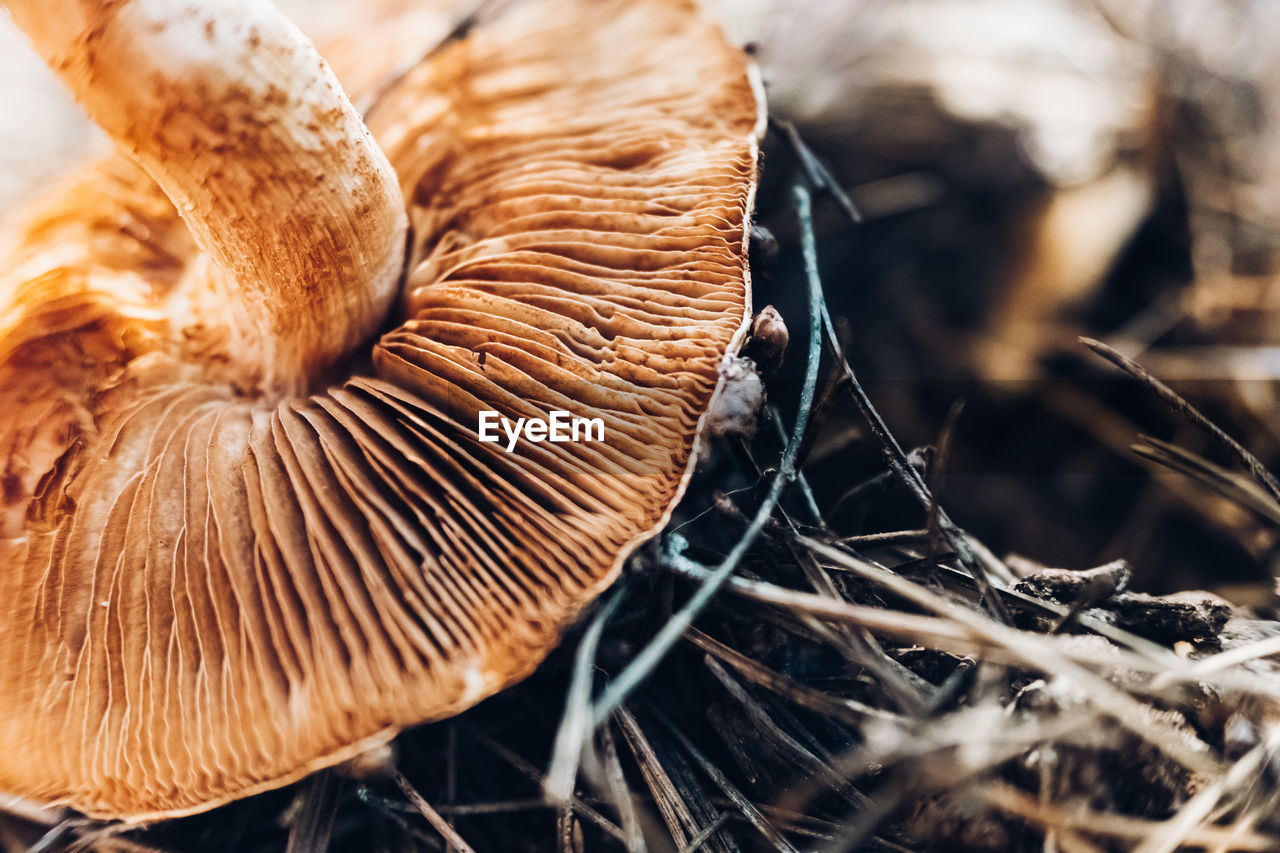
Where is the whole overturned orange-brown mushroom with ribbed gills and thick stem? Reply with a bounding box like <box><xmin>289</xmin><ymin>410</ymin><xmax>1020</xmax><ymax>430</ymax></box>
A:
<box><xmin>0</xmin><ymin>0</ymin><xmax>760</xmax><ymax>821</ymax></box>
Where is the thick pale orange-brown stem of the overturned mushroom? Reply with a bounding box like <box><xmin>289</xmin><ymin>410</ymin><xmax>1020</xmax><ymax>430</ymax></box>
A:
<box><xmin>0</xmin><ymin>0</ymin><xmax>407</xmax><ymax>393</ymax></box>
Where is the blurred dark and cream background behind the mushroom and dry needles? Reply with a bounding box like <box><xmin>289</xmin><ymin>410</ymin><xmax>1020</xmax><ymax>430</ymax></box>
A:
<box><xmin>0</xmin><ymin>0</ymin><xmax>1280</xmax><ymax>596</ymax></box>
